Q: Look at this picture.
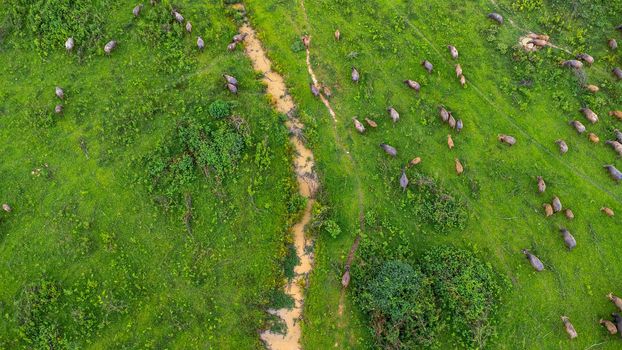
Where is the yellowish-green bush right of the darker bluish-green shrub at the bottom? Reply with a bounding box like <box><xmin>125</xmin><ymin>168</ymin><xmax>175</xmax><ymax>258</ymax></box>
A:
<box><xmin>421</xmin><ymin>246</ymin><xmax>502</xmax><ymax>348</ymax></box>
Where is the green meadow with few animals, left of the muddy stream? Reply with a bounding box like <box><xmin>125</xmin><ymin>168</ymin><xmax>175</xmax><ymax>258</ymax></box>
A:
<box><xmin>0</xmin><ymin>0</ymin><xmax>304</xmax><ymax>349</ymax></box>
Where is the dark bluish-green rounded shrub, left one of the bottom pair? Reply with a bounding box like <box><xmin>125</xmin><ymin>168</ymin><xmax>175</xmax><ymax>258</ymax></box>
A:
<box><xmin>357</xmin><ymin>261</ymin><xmax>440</xmax><ymax>349</ymax></box>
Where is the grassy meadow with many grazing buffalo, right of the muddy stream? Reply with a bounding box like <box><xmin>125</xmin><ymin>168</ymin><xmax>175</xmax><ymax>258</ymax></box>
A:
<box><xmin>246</xmin><ymin>0</ymin><xmax>622</xmax><ymax>349</ymax></box>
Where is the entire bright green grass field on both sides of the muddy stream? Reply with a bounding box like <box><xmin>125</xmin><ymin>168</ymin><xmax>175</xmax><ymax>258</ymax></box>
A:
<box><xmin>0</xmin><ymin>0</ymin><xmax>622</xmax><ymax>349</ymax></box>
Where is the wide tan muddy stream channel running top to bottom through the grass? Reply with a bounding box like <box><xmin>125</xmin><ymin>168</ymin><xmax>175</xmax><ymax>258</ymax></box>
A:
<box><xmin>234</xmin><ymin>4</ymin><xmax>319</xmax><ymax>350</ymax></box>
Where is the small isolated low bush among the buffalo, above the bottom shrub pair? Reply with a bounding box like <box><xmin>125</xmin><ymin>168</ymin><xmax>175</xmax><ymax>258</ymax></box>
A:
<box><xmin>408</xmin><ymin>173</ymin><xmax>468</xmax><ymax>233</ymax></box>
